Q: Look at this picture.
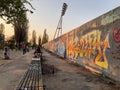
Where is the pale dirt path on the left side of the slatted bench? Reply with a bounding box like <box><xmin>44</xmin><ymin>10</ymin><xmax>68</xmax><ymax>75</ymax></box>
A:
<box><xmin>0</xmin><ymin>51</ymin><xmax>33</xmax><ymax>90</ymax></box>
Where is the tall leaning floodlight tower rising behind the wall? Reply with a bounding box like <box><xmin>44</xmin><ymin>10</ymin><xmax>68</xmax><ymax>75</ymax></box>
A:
<box><xmin>53</xmin><ymin>3</ymin><xmax>67</xmax><ymax>39</ymax></box>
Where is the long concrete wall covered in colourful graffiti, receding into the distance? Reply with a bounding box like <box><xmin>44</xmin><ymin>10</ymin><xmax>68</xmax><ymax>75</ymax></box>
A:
<box><xmin>44</xmin><ymin>7</ymin><xmax>120</xmax><ymax>81</ymax></box>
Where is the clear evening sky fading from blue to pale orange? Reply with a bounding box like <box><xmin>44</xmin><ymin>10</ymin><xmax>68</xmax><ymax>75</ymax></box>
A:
<box><xmin>2</xmin><ymin>0</ymin><xmax>120</xmax><ymax>40</ymax></box>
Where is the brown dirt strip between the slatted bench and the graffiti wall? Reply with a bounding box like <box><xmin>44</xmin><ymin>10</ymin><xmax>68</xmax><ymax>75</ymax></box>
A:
<box><xmin>42</xmin><ymin>51</ymin><xmax>120</xmax><ymax>90</ymax></box>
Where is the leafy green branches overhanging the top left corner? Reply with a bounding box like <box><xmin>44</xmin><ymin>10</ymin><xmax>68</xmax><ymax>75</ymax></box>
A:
<box><xmin>0</xmin><ymin>0</ymin><xmax>34</xmax><ymax>25</ymax></box>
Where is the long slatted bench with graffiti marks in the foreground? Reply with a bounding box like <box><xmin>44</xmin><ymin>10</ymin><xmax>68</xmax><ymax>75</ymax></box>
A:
<box><xmin>16</xmin><ymin>58</ymin><xmax>43</xmax><ymax>90</ymax></box>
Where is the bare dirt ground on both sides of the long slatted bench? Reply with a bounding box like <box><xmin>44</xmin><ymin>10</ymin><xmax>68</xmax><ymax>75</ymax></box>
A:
<box><xmin>0</xmin><ymin>50</ymin><xmax>120</xmax><ymax>90</ymax></box>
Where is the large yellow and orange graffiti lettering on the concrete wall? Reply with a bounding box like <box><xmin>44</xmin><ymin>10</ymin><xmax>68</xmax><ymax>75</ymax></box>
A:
<box><xmin>68</xmin><ymin>30</ymin><xmax>110</xmax><ymax>69</ymax></box>
